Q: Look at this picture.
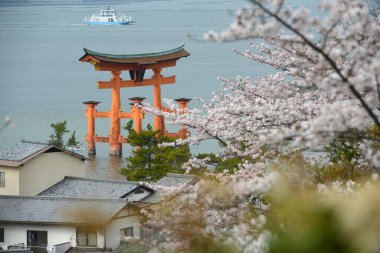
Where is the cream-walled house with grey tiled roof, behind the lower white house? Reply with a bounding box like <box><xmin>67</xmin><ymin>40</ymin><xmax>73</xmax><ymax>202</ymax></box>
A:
<box><xmin>0</xmin><ymin>141</ymin><xmax>87</xmax><ymax>196</ymax></box>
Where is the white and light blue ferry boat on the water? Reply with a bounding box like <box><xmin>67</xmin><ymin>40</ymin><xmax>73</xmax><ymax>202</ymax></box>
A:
<box><xmin>84</xmin><ymin>7</ymin><xmax>133</xmax><ymax>25</ymax></box>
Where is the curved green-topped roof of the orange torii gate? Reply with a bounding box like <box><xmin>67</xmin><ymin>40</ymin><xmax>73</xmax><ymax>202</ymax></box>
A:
<box><xmin>79</xmin><ymin>44</ymin><xmax>190</xmax><ymax>64</ymax></box>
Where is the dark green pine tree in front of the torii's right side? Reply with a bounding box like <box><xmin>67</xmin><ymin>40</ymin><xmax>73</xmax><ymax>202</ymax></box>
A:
<box><xmin>120</xmin><ymin>121</ymin><xmax>190</xmax><ymax>181</ymax></box>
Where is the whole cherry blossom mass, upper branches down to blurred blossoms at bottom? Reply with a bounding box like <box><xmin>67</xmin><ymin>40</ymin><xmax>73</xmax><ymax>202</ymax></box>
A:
<box><xmin>138</xmin><ymin>0</ymin><xmax>380</xmax><ymax>252</ymax></box>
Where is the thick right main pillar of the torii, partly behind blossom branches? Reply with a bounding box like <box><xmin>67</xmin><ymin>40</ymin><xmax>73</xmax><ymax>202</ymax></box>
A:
<box><xmin>153</xmin><ymin>68</ymin><xmax>165</xmax><ymax>134</ymax></box>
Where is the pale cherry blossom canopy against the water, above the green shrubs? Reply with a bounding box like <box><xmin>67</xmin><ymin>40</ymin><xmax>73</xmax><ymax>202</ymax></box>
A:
<box><xmin>160</xmin><ymin>0</ymin><xmax>380</xmax><ymax>158</ymax></box>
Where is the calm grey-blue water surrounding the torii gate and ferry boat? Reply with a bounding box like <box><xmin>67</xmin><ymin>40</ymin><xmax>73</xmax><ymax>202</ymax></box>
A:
<box><xmin>0</xmin><ymin>0</ymin><xmax>314</xmax><ymax>178</ymax></box>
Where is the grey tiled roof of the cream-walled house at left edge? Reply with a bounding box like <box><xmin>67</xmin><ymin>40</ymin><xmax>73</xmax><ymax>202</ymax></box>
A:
<box><xmin>0</xmin><ymin>141</ymin><xmax>87</xmax><ymax>167</ymax></box>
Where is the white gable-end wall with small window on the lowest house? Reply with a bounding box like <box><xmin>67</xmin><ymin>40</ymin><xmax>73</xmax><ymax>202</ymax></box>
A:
<box><xmin>105</xmin><ymin>215</ymin><xmax>141</xmax><ymax>250</ymax></box>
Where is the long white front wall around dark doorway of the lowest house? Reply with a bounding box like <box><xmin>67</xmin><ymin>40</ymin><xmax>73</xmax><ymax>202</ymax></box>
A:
<box><xmin>0</xmin><ymin>224</ymin><xmax>76</xmax><ymax>246</ymax></box>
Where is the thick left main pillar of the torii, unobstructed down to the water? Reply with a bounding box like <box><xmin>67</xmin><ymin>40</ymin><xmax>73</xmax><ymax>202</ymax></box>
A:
<box><xmin>109</xmin><ymin>71</ymin><xmax>122</xmax><ymax>156</ymax></box>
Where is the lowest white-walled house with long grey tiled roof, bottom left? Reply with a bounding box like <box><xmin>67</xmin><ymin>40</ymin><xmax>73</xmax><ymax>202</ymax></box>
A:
<box><xmin>0</xmin><ymin>196</ymin><xmax>130</xmax><ymax>250</ymax></box>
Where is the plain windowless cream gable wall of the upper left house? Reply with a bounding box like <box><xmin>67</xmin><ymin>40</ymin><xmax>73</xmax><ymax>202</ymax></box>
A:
<box><xmin>19</xmin><ymin>152</ymin><xmax>85</xmax><ymax>196</ymax></box>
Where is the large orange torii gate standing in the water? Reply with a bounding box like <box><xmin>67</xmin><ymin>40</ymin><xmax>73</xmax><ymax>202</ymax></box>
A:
<box><xmin>79</xmin><ymin>44</ymin><xmax>190</xmax><ymax>156</ymax></box>
